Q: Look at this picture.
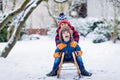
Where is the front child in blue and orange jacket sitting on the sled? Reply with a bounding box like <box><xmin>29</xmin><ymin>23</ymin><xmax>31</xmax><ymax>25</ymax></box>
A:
<box><xmin>47</xmin><ymin>28</ymin><xmax>92</xmax><ymax>76</ymax></box>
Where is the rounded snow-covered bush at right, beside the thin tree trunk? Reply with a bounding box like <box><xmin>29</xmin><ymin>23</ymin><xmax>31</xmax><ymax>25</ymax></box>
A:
<box><xmin>93</xmin><ymin>19</ymin><xmax>114</xmax><ymax>43</ymax></box>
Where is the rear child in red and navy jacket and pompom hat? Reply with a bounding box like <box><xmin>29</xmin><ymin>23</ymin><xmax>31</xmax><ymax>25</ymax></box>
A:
<box><xmin>55</xmin><ymin>13</ymin><xmax>79</xmax><ymax>45</ymax></box>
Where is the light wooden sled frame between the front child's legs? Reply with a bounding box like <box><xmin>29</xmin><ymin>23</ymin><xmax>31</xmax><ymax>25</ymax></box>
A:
<box><xmin>57</xmin><ymin>52</ymin><xmax>81</xmax><ymax>78</ymax></box>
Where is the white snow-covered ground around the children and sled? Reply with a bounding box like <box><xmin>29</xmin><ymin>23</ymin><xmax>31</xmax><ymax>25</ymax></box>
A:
<box><xmin>0</xmin><ymin>36</ymin><xmax>120</xmax><ymax>80</ymax></box>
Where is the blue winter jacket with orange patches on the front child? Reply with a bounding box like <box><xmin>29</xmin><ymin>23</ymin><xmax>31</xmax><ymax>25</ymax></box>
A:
<box><xmin>54</xmin><ymin>41</ymin><xmax>82</xmax><ymax>59</ymax></box>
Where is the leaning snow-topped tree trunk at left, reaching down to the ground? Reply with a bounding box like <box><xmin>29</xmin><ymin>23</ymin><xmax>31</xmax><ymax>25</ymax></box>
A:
<box><xmin>1</xmin><ymin>0</ymin><xmax>45</xmax><ymax>58</ymax></box>
